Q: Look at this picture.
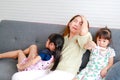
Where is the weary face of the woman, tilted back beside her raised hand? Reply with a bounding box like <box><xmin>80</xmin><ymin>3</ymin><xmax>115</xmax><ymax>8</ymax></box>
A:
<box><xmin>69</xmin><ymin>16</ymin><xmax>82</xmax><ymax>34</ymax></box>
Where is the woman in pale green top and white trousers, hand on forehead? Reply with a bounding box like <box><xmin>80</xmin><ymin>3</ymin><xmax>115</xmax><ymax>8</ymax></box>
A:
<box><xmin>12</xmin><ymin>15</ymin><xmax>92</xmax><ymax>80</ymax></box>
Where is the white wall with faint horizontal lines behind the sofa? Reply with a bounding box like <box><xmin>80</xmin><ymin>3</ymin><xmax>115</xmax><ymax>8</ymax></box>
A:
<box><xmin>0</xmin><ymin>0</ymin><xmax>120</xmax><ymax>28</ymax></box>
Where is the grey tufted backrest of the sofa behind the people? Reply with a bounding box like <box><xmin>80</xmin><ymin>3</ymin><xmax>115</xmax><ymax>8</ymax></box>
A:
<box><xmin>0</xmin><ymin>20</ymin><xmax>120</xmax><ymax>62</ymax></box>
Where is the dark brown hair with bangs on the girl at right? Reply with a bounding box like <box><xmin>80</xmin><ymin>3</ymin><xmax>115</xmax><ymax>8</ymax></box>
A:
<box><xmin>95</xmin><ymin>27</ymin><xmax>112</xmax><ymax>45</ymax></box>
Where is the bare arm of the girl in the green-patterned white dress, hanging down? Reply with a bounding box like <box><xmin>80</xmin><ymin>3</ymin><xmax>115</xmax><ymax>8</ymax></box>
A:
<box><xmin>100</xmin><ymin>57</ymin><xmax>114</xmax><ymax>78</ymax></box>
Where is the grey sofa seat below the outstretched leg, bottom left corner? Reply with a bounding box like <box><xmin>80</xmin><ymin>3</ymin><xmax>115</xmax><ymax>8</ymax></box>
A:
<box><xmin>0</xmin><ymin>59</ymin><xmax>17</xmax><ymax>80</ymax></box>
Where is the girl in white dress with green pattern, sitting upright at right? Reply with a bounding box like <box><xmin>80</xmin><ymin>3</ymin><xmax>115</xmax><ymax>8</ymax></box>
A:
<box><xmin>73</xmin><ymin>28</ymin><xmax>115</xmax><ymax>80</ymax></box>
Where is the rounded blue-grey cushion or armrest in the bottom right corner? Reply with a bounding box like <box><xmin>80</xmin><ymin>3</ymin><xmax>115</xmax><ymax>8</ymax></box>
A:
<box><xmin>105</xmin><ymin>61</ymin><xmax>120</xmax><ymax>80</ymax></box>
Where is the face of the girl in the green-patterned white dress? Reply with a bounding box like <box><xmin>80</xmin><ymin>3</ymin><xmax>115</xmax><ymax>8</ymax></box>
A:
<box><xmin>97</xmin><ymin>37</ymin><xmax>110</xmax><ymax>48</ymax></box>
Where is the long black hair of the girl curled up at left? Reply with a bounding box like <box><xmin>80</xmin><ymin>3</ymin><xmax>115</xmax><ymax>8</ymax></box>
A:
<box><xmin>48</xmin><ymin>33</ymin><xmax>64</xmax><ymax>70</ymax></box>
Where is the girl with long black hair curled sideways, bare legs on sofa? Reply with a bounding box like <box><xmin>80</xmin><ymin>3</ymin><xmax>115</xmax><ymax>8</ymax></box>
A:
<box><xmin>0</xmin><ymin>34</ymin><xmax>64</xmax><ymax>71</ymax></box>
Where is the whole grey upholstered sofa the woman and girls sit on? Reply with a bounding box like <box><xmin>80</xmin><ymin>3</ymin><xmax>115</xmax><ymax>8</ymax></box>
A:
<box><xmin>0</xmin><ymin>20</ymin><xmax>120</xmax><ymax>80</ymax></box>
